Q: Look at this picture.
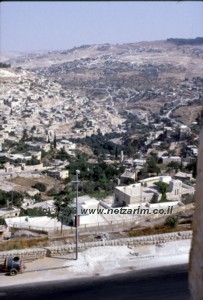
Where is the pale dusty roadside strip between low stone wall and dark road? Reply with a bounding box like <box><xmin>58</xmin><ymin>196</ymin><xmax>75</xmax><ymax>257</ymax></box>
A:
<box><xmin>0</xmin><ymin>240</ymin><xmax>191</xmax><ymax>286</ymax></box>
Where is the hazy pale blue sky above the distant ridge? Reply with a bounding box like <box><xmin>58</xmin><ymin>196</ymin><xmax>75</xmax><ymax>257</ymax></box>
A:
<box><xmin>0</xmin><ymin>1</ymin><xmax>203</xmax><ymax>51</ymax></box>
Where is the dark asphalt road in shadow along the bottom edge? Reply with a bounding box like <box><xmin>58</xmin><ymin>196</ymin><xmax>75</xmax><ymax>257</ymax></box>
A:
<box><xmin>0</xmin><ymin>265</ymin><xmax>189</xmax><ymax>300</ymax></box>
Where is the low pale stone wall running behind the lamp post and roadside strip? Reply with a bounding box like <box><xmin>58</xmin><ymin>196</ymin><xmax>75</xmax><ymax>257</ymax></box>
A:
<box><xmin>0</xmin><ymin>231</ymin><xmax>192</xmax><ymax>261</ymax></box>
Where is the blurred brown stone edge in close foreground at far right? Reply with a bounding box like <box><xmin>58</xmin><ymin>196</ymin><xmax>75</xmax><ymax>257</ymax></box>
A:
<box><xmin>189</xmin><ymin>109</ymin><xmax>203</xmax><ymax>300</ymax></box>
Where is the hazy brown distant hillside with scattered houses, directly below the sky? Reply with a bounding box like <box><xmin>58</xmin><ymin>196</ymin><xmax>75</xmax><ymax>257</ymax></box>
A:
<box><xmin>2</xmin><ymin>37</ymin><xmax>203</xmax><ymax>123</ymax></box>
